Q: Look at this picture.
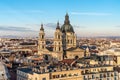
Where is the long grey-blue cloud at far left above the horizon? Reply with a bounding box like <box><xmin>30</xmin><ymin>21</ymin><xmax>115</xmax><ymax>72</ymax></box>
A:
<box><xmin>0</xmin><ymin>26</ymin><xmax>34</xmax><ymax>32</ymax></box>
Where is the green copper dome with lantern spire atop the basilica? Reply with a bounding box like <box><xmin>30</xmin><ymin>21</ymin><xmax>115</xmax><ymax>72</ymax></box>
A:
<box><xmin>61</xmin><ymin>14</ymin><xmax>74</xmax><ymax>32</ymax></box>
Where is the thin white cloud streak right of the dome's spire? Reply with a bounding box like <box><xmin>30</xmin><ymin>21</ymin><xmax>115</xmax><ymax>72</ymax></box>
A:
<box><xmin>71</xmin><ymin>12</ymin><xmax>112</xmax><ymax>16</ymax></box>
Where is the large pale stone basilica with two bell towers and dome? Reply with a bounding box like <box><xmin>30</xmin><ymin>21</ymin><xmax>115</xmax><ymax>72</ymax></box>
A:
<box><xmin>38</xmin><ymin>13</ymin><xmax>89</xmax><ymax>61</ymax></box>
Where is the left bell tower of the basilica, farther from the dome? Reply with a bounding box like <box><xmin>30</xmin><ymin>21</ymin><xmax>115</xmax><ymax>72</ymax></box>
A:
<box><xmin>38</xmin><ymin>24</ymin><xmax>46</xmax><ymax>54</ymax></box>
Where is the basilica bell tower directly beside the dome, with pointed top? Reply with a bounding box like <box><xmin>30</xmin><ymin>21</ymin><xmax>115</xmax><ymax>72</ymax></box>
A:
<box><xmin>53</xmin><ymin>22</ymin><xmax>63</xmax><ymax>52</ymax></box>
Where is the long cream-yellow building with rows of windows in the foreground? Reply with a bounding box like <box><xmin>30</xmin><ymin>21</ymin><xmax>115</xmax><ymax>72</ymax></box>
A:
<box><xmin>17</xmin><ymin>65</ymin><xmax>119</xmax><ymax>80</ymax></box>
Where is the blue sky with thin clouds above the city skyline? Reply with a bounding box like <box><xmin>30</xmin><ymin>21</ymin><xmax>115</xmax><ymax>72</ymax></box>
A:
<box><xmin>0</xmin><ymin>0</ymin><xmax>120</xmax><ymax>37</ymax></box>
